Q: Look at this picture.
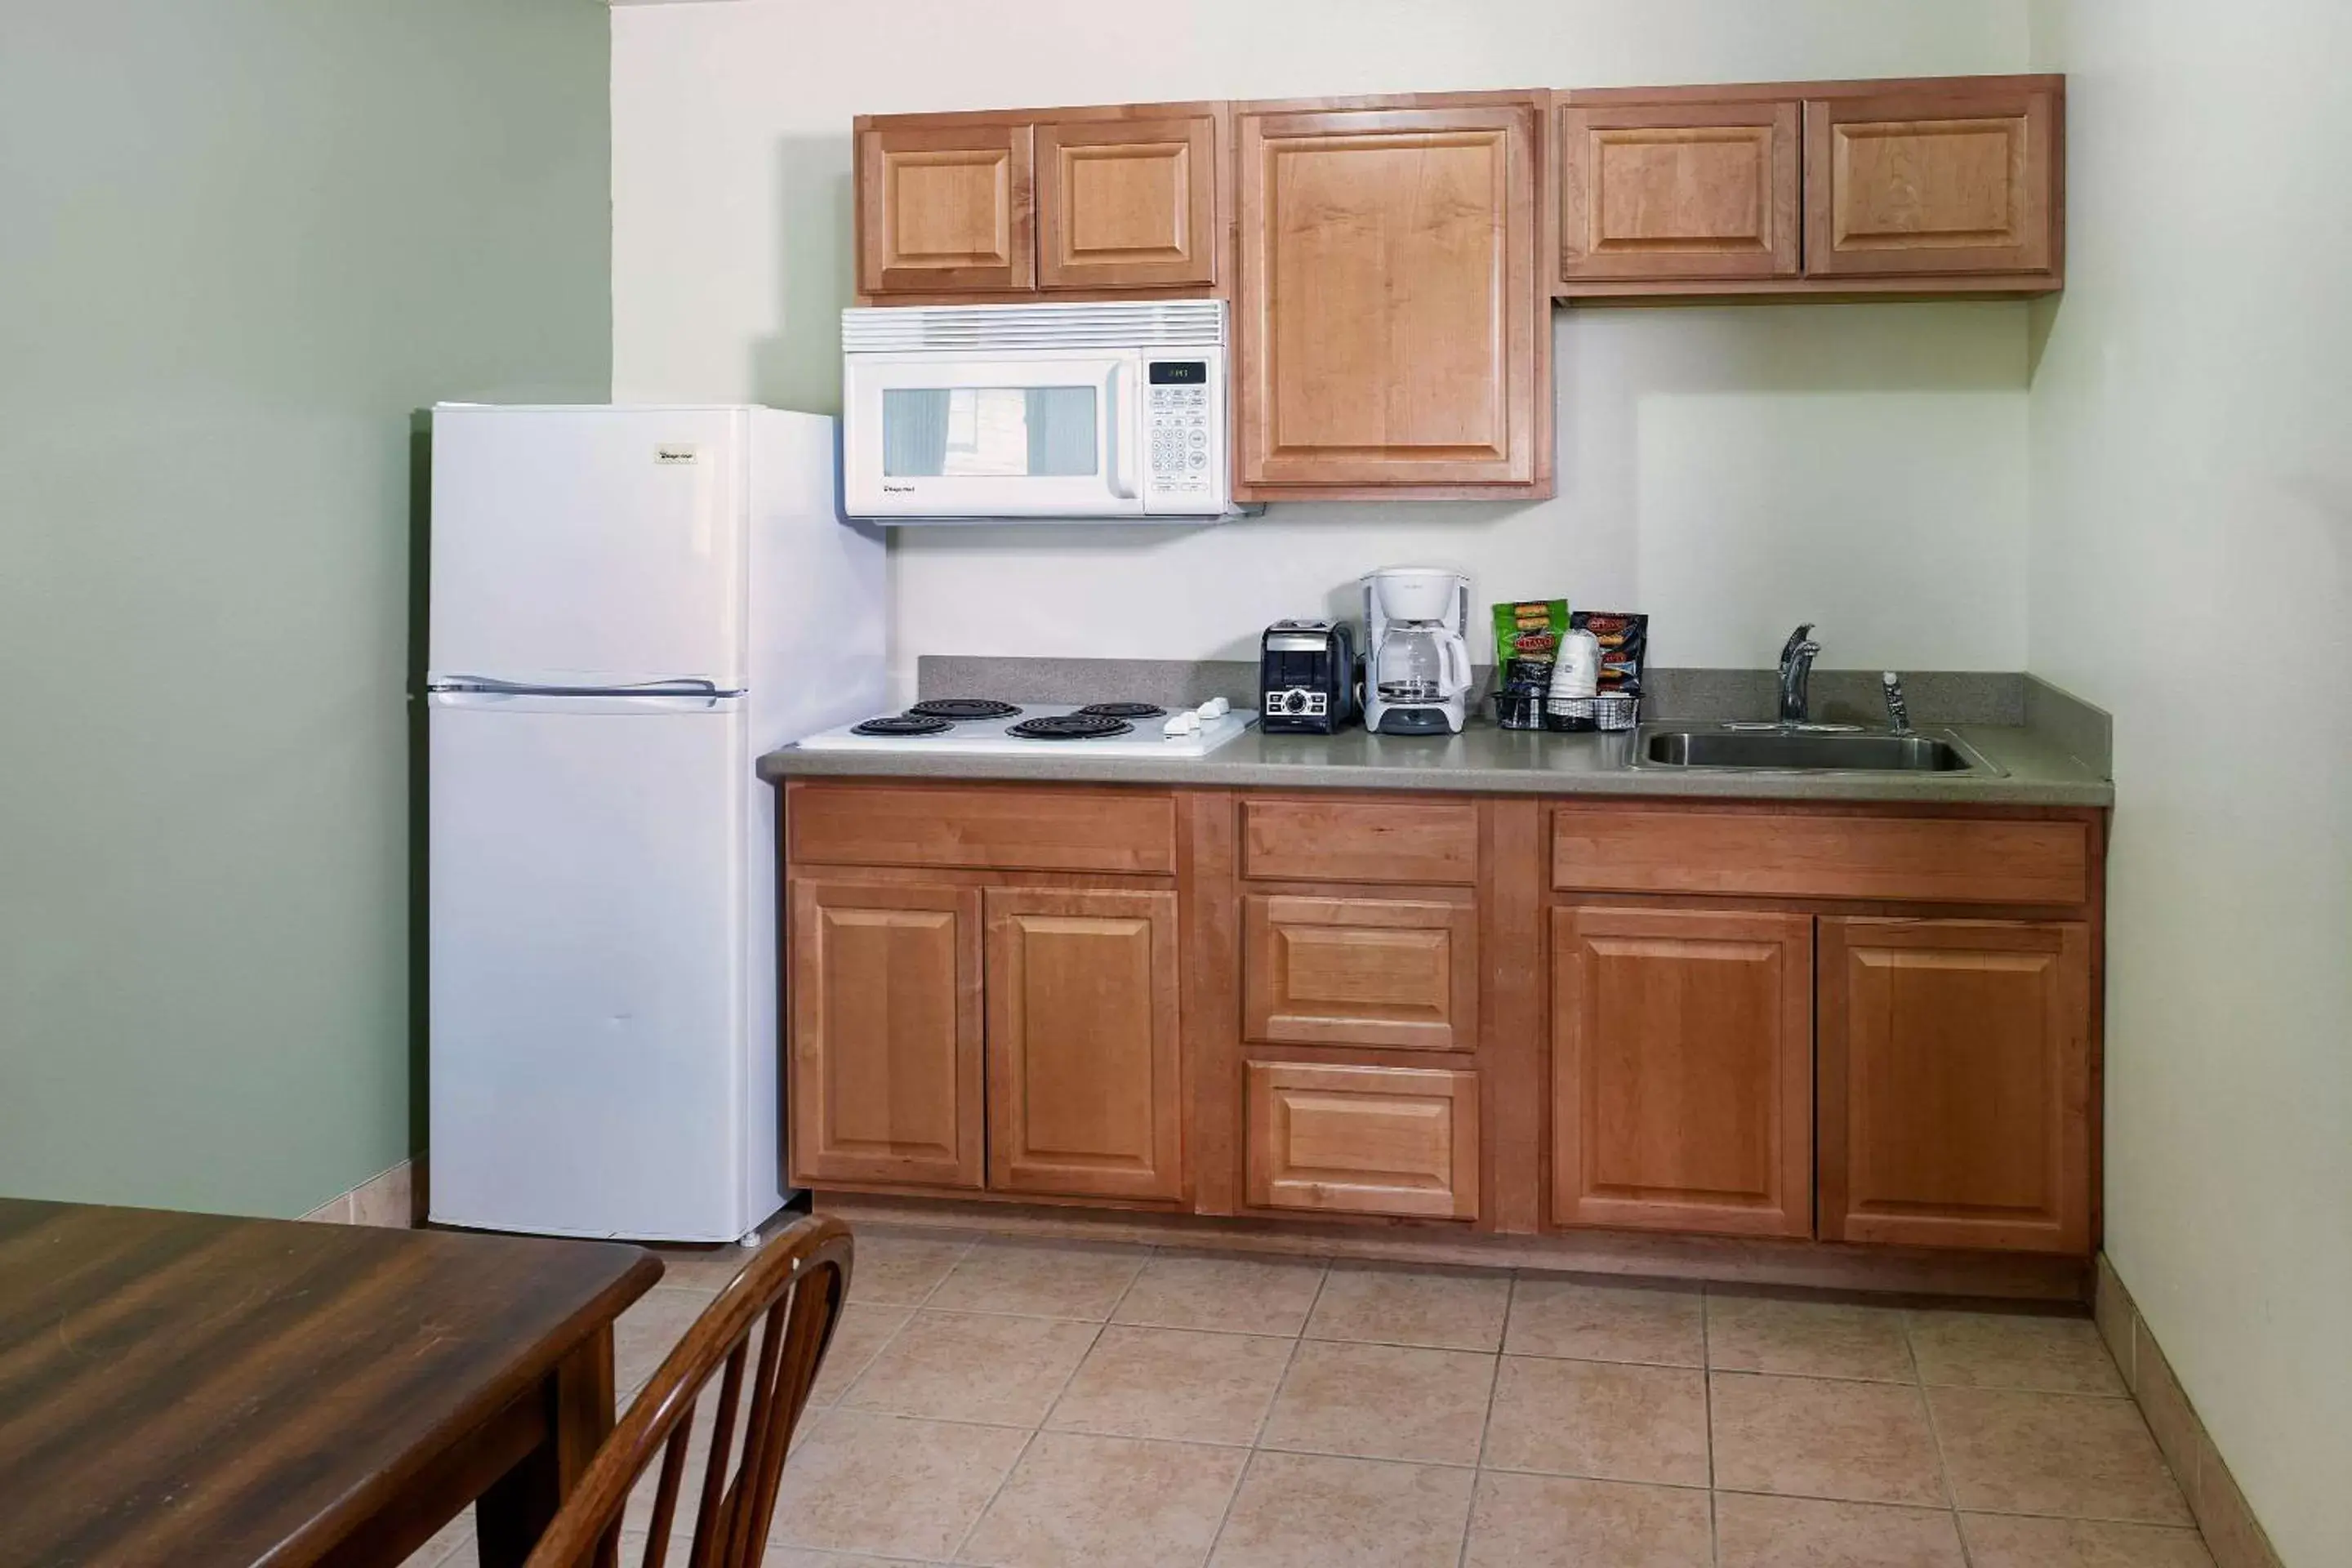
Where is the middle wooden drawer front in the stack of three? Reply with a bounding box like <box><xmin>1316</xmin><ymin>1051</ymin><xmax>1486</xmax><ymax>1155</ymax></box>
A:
<box><xmin>1242</xmin><ymin>893</ymin><xmax>1477</xmax><ymax>1051</ymax></box>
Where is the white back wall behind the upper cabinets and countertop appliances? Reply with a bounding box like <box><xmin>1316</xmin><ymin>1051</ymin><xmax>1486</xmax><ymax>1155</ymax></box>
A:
<box><xmin>612</xmin><ymin>0</ymin><xmax>2028</xmax><ymax>687</ymax></box>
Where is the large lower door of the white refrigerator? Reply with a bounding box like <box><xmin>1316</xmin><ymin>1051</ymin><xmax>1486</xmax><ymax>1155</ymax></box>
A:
<box><xmin>428</xmin><ymin>693</ymin><xmax>752</xmax><ymax>1241</ymax></box>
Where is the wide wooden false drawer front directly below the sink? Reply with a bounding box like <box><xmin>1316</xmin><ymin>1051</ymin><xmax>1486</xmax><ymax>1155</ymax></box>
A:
<box><xmin>1552</xmin><ymin>806</ymin><xmax>2091</xmax><ymax>905</ymax></box>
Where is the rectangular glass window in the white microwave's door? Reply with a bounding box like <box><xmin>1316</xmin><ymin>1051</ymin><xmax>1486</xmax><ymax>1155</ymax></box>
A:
<box><xmin>882</xmin><ymin>385</ymin><xmax>1098</xmax><ymax>479</ymax></box>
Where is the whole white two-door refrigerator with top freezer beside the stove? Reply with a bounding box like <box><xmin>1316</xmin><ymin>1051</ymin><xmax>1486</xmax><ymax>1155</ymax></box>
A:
<box><xmin>425</xmin><ymin>404</ymin><xmax>884</xmax><ymax>1241</ymax></box>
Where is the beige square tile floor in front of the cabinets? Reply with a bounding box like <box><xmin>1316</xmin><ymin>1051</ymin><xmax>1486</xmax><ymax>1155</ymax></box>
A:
<box><xmin>394</xmin><ymin>1227</ymin><xmax>2211</xmax><ymax>1568</ymax></box>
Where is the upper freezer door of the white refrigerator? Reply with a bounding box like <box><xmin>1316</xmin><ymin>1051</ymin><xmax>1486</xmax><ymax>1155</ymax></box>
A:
<box><xmin>428</xmin><ymin>407</ymin><xmax>746</xmax><ymax>691</ymax></box>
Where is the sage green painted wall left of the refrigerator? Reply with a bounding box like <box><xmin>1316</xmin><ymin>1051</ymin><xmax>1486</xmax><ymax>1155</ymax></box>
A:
<box><xmin>0</xmin><ymin>0</ymin><xmax>612</xmax><ymax>1213</ymax></box>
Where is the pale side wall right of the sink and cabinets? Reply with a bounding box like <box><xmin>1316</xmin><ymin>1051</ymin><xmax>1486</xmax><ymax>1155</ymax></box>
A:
<box><xmin>2029</xmin><ymin>0</ymin><xmax>2352</xmax><ymax>1568</ymax></box>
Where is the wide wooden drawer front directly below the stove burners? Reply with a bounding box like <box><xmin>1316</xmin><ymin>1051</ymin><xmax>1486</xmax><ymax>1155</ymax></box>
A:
<box><xmin>786</xmin><ymin>783</ymin><xmax>1176</xmax><ymax>877</ymax></box>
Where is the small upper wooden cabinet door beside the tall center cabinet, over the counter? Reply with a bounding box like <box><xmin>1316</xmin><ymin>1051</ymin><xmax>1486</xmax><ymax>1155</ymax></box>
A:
<box><xmin>1559</xmin><ymin>101</ymin><xmax>1804</xmax><ymax>284</ymax></box>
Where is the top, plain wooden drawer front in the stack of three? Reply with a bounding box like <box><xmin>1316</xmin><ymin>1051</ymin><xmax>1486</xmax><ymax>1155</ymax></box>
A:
<box><xmin>1242</xmin><ymin>800</ymin><xmax>1477</xmax><ymax>886</ymax></box>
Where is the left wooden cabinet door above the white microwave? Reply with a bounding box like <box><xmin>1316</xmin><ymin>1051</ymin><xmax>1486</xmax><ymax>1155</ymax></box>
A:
<box><xmin>858</xmin><ymin>125</ymin><xmax>1037</xmax><ymax>294</ymax></box>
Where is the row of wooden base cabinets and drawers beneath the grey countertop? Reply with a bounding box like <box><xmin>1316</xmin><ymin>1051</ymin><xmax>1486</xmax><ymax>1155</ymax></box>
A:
<box><xmin>778</xmin><ymin>778</ymin><xmax>2105</xmax><ymax>1293</ymax></box>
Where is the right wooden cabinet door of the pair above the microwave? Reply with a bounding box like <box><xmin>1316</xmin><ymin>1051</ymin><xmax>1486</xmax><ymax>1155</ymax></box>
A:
<box><xmin>1037</xmin><ymin>113</ymin><xmax>1218</xmax><ymax>289</ymax></box>
